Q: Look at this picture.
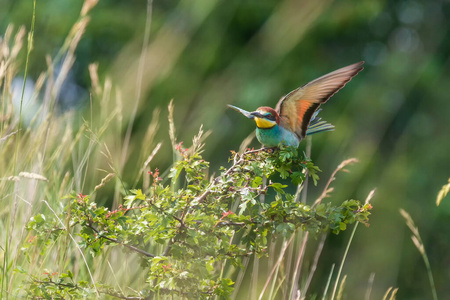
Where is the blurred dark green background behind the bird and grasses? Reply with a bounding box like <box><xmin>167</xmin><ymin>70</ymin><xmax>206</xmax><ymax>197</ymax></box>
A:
<box><xmin>0</xmin><ymin>0</ymin><xmax>450</xmax><ymax>299</ymax></box>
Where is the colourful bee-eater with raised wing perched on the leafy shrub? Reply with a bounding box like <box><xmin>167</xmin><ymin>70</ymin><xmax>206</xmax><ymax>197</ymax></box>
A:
<box><xmin>228</xmin><ymin>61</ymin><xmax>364</xmax><ymax>148</ymax></box>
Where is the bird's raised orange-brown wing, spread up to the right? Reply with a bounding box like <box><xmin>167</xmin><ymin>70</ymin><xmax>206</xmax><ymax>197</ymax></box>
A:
<box><xmin>275</xmin><ymin>61</ymin><xmax>364</xmax><ymax>140</ymax></box>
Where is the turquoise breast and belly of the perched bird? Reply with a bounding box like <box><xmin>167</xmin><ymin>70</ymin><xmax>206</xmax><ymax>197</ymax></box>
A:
<box><xmin>256</xmin><ymin>125</ymin><xmax>299</xmax><ymax>147</ymax></box>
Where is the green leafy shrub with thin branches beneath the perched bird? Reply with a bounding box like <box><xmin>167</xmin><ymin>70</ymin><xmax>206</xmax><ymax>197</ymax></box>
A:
<box><xmin>27</xmin><ymin>144</ymin><xmax>371</xmax><ymax>299</ymax></box>
